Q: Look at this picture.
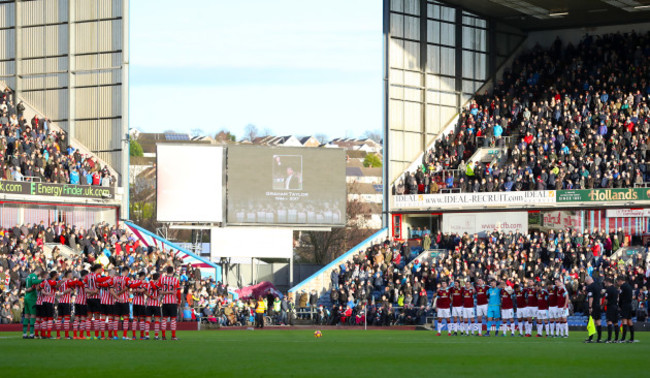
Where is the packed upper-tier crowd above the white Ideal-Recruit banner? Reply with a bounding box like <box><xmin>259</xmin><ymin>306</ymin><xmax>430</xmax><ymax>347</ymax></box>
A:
<box><xmin>393</xmin><ymin>33</ymin><xmax>650</xmax><ymax>194</ymax></box>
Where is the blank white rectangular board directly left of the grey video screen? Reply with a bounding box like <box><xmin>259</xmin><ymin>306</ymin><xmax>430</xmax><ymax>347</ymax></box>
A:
<box><xmin>156</xmin><ymin>144</ymin><xmax>224</xmax><ymax>223</ymax></box>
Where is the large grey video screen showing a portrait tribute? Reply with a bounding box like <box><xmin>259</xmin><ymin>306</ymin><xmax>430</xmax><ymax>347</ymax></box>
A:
<box><xmin>227</xmin><ymin>146</ymin><xmax>346</xmax><ymax>225</ymax></box>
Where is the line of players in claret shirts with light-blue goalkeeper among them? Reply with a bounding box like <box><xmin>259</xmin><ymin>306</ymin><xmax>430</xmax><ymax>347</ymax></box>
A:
<box><xmin>433</xmin><ymin>279</ymin><xmax>569</xmax><ymax>338</ymax></box>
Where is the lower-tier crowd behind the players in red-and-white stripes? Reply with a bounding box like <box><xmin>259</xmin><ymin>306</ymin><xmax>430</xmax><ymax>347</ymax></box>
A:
<box><xmin>0</xmin><ymin>222</ymin><xmax>228</xmax><ymax>323</ymax></box>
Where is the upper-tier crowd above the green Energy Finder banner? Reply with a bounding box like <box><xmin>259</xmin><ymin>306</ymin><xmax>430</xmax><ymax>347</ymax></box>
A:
<box><xmin>0</xmin><ymin>83</ymin><xmax>117</xmax><ymax>186</ymax></box>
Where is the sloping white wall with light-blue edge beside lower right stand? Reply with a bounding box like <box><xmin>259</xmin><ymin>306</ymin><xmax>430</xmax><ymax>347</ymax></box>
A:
<box><xmin>289</xmin><ymin>228</ymin><xmax>388</xmax><ymax>306</ymax></box>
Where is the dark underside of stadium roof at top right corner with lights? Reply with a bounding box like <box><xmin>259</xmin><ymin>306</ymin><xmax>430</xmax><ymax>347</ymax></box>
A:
<box><xmin>443</xmin><ymin>0</ymin><xmax>650</xmax><ymax>31</ymax></box>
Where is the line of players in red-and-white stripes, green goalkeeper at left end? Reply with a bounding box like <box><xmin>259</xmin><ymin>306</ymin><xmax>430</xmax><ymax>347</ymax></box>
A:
<box><xmin>23</xmin><ymin>264</ymin><xmax>180</xmax><ymax>340</ymax></box>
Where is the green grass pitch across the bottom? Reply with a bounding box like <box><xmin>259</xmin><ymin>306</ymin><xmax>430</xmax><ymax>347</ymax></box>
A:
<box><xmin>0</xmin><ymin>330</ymin><xmax>650</xmax><ymax>378</ymax></box>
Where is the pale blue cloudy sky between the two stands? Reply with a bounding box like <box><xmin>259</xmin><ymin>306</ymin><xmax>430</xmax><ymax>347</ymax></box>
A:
<box><xmin>129</xmin><ymin>0</ymin><xmax>383</xmax><ymax>139</ymax></box>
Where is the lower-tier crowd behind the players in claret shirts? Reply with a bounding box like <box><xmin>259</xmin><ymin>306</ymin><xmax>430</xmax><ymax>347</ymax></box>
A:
<box><xmin>312</xmin><ymin>230</ymin><xmax>650</xmax><ymax>325</ymax></box>
